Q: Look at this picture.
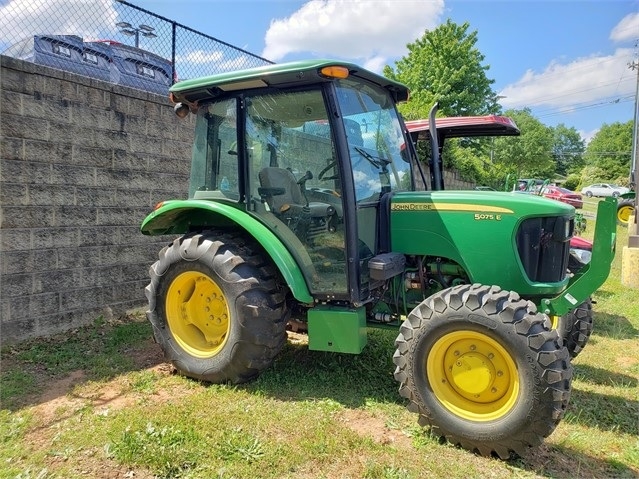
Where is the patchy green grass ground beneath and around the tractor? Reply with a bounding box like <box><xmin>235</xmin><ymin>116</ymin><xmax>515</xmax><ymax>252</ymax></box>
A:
<box><xmin>0</xmin><ymin>226</ymin><xmax>639</xmax><ymax>479</ymax></box>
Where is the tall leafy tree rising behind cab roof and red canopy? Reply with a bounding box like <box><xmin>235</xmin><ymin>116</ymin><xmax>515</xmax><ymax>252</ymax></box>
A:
<box><xmin>384</xmin><ymin>20</ymin><xmax>500</xmax><ymax>120</ymax></box>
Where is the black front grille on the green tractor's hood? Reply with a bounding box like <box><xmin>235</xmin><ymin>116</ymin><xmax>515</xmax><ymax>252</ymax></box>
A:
<box><xmin>517</xmin><ymin>216</ymin><xmax>575</xmax><ymax>283</ymax></box>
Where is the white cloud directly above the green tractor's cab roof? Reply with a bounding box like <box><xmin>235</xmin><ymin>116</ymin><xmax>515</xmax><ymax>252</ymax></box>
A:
<box><xmin>261</xmin><ymin>0</ymin><xmax>444</xmax><ymax>71</ymax></box>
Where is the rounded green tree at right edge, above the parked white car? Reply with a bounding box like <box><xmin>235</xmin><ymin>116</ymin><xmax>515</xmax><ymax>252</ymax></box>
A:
<box><xmin>582</xmin><ymin>121</ymin><xmax>633</xmax><ymax>185</ymax></box>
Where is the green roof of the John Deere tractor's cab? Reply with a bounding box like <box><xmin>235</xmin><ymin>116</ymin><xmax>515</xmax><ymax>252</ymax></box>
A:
<box><xmin>169</xmin><ymin>59</ymin><xmax>408</xmax><ymax>103</ymax></box>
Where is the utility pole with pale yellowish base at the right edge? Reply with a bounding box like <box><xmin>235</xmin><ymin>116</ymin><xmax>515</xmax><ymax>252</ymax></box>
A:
<box><xmin>621</xmin><ymin>61</ymin><xmax>639</xmax><ymax>288</ymax></box>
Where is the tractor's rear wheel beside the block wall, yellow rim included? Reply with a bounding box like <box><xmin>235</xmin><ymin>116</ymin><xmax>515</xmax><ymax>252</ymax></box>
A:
<box><xmin>145</xmin><ymin>231</ymin><xmax>289</xmax><ymax>383</ymax></box>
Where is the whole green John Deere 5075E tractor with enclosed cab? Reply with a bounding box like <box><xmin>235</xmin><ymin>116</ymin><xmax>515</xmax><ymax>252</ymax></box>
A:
<box><xmin>141</xmin><ymin>60</ymin><xmax>616</xmax><ymax>458</ymax></box>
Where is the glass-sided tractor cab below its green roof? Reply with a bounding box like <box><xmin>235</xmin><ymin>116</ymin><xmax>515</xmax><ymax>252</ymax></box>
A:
<box><xmin>165</xmin><ymin>62</ymin><xmax>412</xmax><ymax>305</ymax></box>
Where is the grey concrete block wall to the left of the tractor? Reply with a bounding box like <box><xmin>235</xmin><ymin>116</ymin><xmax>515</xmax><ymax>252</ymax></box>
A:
<box><xmin>0</xmin><ymin>56</ymin><xmax>193</xmax><ymax>344</ymax></box>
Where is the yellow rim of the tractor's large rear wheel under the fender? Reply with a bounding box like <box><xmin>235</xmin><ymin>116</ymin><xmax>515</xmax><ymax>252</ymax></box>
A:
<box><xmin>166</xmin><ymin>271</ymin><xmax>230</xmax><ymax>358</ymax></box>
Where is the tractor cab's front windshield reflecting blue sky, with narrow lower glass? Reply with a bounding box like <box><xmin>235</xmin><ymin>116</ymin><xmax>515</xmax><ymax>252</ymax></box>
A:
<box><xmin>336</xmin><ymin>79</ymin><xmax>413</xmax><ymax>303</ymax></box>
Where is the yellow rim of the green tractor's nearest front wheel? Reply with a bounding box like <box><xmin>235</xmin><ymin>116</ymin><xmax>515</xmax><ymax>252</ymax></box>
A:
<box><xmin>426</xmin><ymin>331</ymin><xmax>519</xmax><ymax>421</ymax></box>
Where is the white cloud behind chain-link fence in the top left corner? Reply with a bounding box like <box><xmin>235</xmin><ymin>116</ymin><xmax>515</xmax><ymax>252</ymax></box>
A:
<box><xmin>0</xmin><ymin>0</ymin><xmax>118</xmax><ymax>44</ymax></box>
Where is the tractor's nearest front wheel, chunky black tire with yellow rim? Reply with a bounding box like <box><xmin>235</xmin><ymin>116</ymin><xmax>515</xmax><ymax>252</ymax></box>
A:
<box><xmin>393</xmin><ymin>284</ymin><xmax>572</xmax><ymax>459</ymax></box>
